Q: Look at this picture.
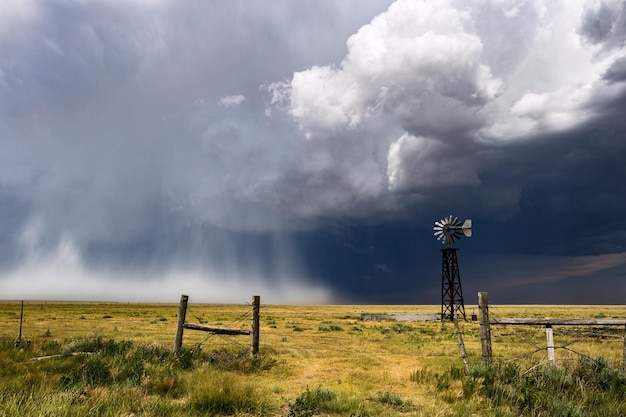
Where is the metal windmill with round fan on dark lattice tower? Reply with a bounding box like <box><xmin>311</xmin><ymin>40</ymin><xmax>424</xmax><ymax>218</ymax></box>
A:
<box><xmin>433</xmin><ymin>215</ymin><xmax>472</xmax><ymax>320</ymax></box>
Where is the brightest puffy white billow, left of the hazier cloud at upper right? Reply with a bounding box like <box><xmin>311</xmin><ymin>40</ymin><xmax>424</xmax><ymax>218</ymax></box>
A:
<box><xmin>273</xmin><ymin>1</ymin><xmax>500</xmax><ymax>137</ymax></box>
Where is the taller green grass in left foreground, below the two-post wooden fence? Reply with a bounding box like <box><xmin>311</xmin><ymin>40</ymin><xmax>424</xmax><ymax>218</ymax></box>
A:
<box><xmin>0</xmin><ymin>337</ymin><xmax>275</xmax><ymax>417</ymax></box>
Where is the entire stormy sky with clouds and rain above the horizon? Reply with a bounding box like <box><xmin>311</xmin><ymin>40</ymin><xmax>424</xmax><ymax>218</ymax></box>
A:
<box><xmin>0</xmin><ymin>0</ymin><xmax>626</xmax><ymax>306</ymax></box>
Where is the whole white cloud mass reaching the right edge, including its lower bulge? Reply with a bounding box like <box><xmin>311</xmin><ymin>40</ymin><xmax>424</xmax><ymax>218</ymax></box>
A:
<box><xmin>269</xmin><ymin>0</ymin><xmax>626</xmax><ymax>200</ymax></box>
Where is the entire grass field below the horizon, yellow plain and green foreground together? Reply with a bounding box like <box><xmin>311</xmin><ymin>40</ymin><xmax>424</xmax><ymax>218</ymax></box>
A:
<box><xmin>0</xmin><ymin>299</ymin><xmax>626</xmax><ymax>417</ymax></box>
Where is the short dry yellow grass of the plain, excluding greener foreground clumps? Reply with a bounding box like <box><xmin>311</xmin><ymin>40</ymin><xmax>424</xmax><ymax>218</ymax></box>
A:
<box><xmin>0</xmin><ymin>300</ymin><xmax>626</xmax><ymax>415</ymax></box>
